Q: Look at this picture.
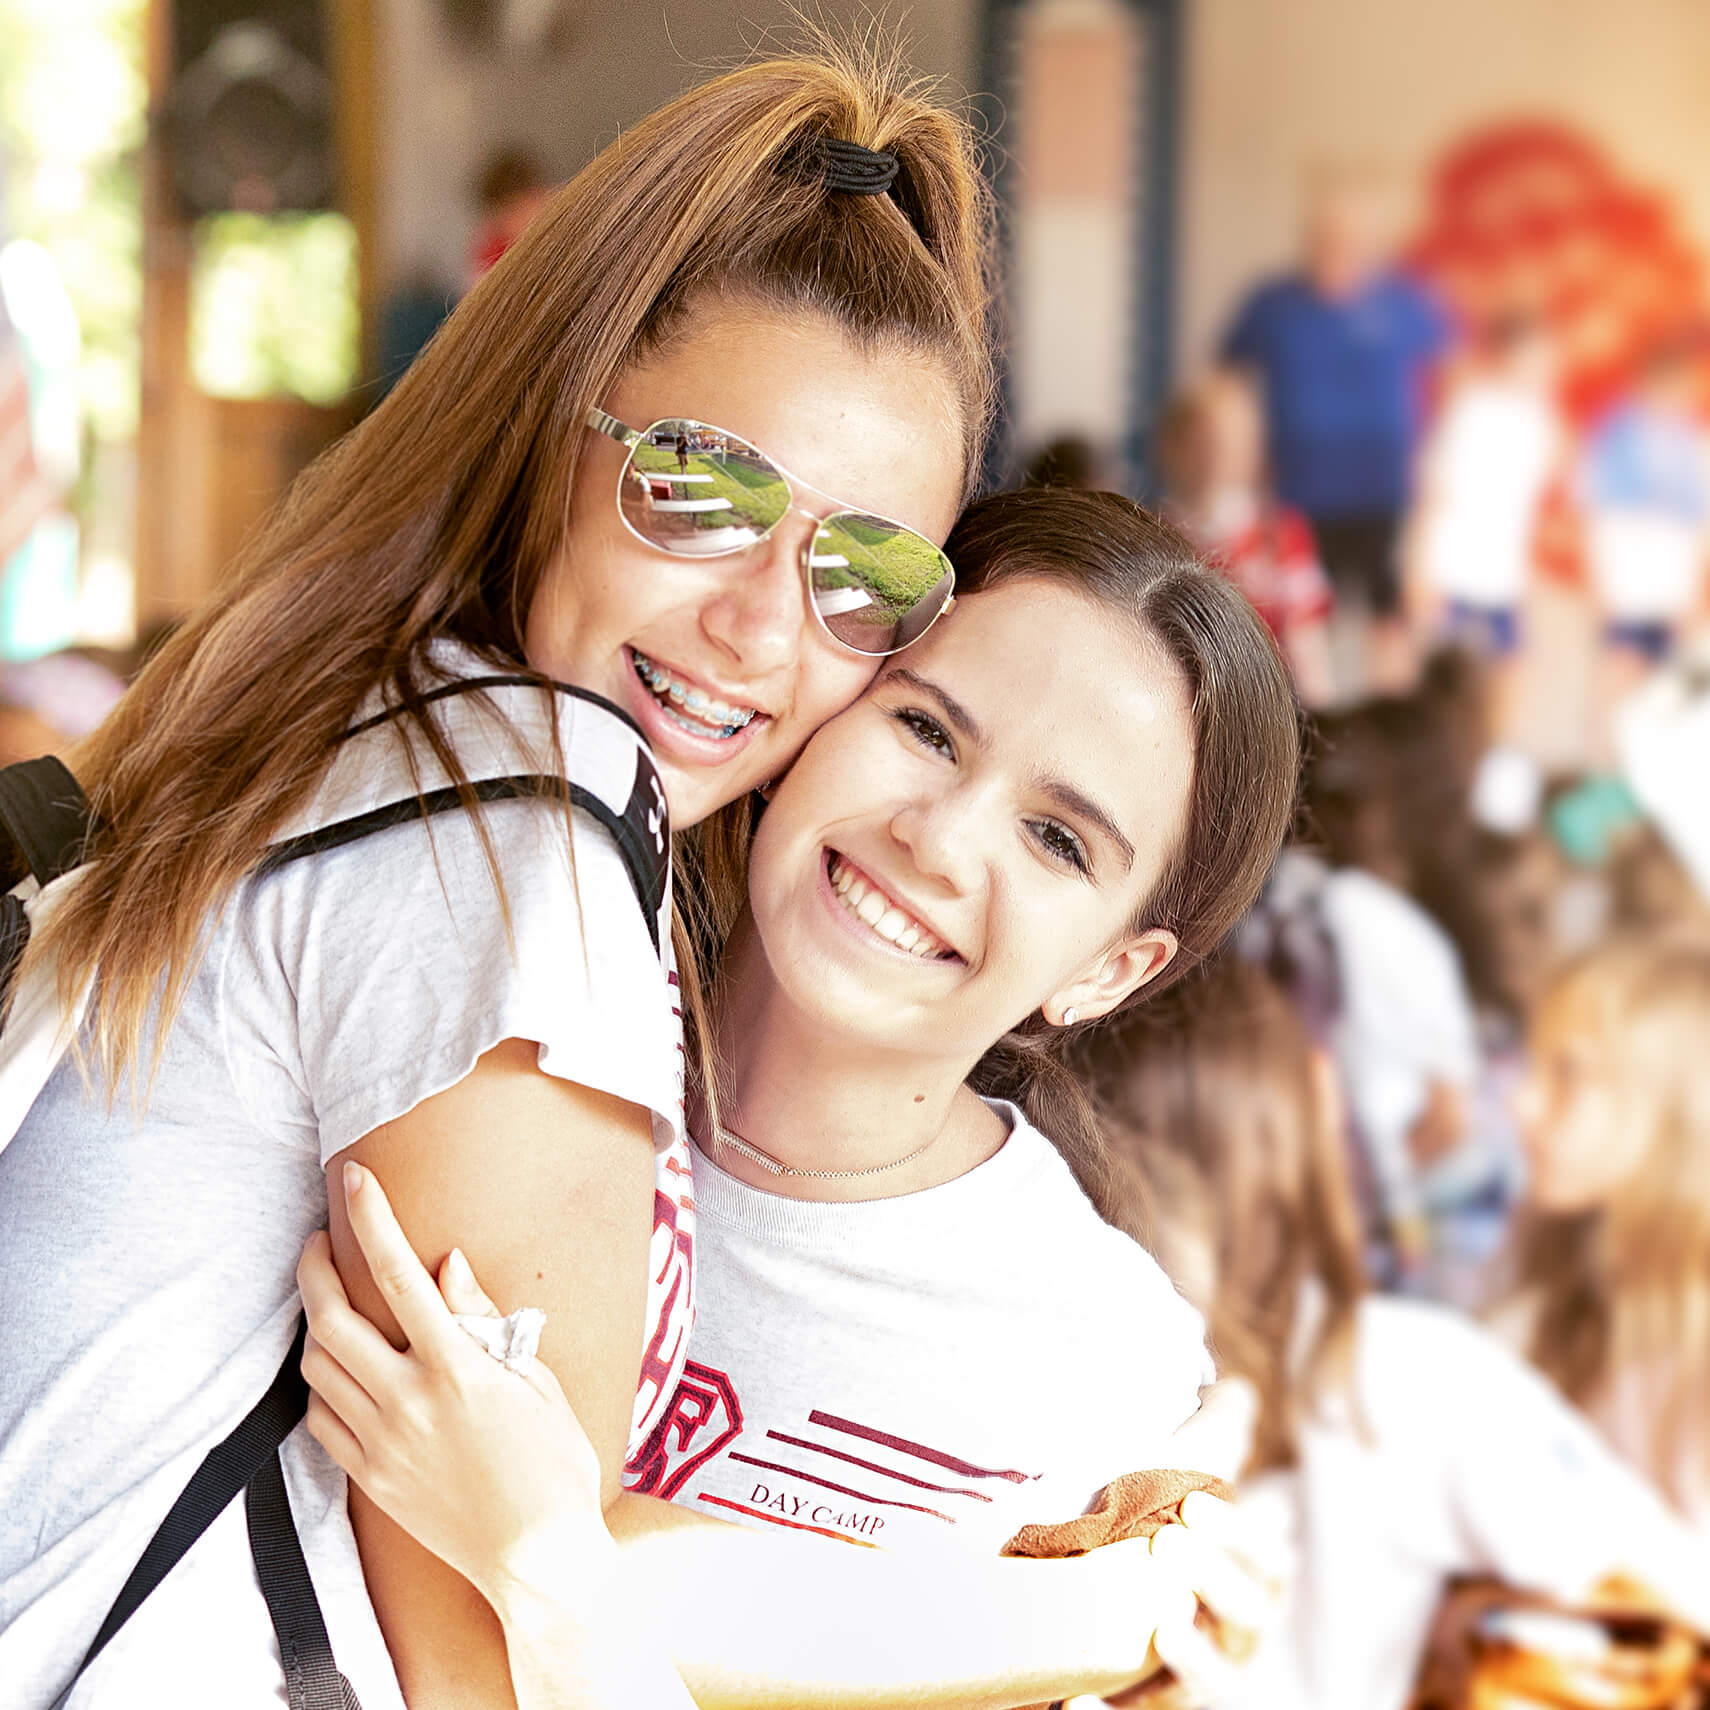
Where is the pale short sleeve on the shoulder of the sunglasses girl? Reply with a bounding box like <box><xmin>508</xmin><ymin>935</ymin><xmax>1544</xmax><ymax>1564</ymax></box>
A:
<box><xmin>224</xmin><ymin>800</ymin><xmax>682</xmax><ymax>1163</ymax></box>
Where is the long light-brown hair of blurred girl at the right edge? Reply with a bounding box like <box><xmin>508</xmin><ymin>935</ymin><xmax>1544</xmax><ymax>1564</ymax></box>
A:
<box><xmin>1515</xmin><ymin>927</ymin><xmax>1710</xmax><ymax>1496</ymax></box>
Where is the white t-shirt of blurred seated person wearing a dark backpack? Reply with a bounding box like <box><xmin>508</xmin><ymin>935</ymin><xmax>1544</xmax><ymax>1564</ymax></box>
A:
<box><xmin>1324</xmin><ymin>867</ymin><xmax>1479</xmax><ymax>1216</ymax></box>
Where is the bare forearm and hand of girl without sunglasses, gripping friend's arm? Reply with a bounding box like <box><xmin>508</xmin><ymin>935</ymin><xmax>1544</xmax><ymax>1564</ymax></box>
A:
<box><xmin>299</xmin><ymin>1183</ymin><xmax>1272</xmax><ymax>1710</ymax></box>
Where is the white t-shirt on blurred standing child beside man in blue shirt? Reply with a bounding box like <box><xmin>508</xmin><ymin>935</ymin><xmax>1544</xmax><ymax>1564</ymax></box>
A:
<box><xmin>1421</xmin><ymin>378</ymin><xmax>1561</xmax><ymax>609</ymax></box>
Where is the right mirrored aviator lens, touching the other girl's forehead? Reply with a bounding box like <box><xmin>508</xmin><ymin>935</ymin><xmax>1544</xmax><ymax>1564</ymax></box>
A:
<box><xmin>807</xmin><ymin>511</ymin><xmax>954</xmax><ymax>653</ymax></box>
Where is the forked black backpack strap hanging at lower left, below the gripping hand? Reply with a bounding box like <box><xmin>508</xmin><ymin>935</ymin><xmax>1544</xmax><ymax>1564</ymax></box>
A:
<box><xmin>55</xmin><ymin>1318</ymin><xmax>357</xmax><ymax>1710</ymax></box>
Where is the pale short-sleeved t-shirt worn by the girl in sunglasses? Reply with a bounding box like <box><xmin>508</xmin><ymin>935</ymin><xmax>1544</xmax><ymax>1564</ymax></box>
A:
<box><xmin>0</xmin><ymin>663</ymin><xmax>693</xmax><ymax>1710</ymax></box>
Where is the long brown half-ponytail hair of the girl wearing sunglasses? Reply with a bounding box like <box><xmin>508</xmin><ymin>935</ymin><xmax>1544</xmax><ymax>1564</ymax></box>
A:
<box><xmin>29</xmin><ymin>48</ymin><xmax>990</xmax><ymax>1086</ymax></box>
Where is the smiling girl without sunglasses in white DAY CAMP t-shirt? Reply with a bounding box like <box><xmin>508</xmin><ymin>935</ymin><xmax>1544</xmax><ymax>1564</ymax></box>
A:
<box><xmin>299</xmin><ymin>491</ymin><xmax>1298</xmax><ymax>1705</ymax></box>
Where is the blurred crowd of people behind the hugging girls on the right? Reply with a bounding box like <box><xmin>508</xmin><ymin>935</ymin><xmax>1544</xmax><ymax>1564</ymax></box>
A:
<box><xmin>1026</xmin><ymin>163</ymin><xmax>1710</xmax><ymax>1710</ymax></box>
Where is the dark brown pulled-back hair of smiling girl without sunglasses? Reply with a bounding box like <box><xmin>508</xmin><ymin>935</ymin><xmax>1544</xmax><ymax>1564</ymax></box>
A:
<box><xmin>946</xmin><ymin>489</ymin><xmax>1300</xmax><ymax>1206</ymax></box>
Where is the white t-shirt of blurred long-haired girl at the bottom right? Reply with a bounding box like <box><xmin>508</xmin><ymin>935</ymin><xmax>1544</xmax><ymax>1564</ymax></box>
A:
<box><xmin>1226</xmin><ymin>1296</ymin><xmax>1710</xmax><ymax>1710</ymax></box>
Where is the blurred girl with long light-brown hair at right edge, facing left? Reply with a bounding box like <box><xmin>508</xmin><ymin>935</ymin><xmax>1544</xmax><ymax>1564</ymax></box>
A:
<box><xmin>1495</xmin><ymin>925</ymin><xmax>1710</xmax><ymax>1539</ymax></box>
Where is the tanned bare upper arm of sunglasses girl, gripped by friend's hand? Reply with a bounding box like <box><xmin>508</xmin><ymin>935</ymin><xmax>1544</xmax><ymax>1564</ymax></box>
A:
<box><xmin>328</xmin><ymin>1040</ymin><xmax>653</xmax><ymax>1710</ymax></box>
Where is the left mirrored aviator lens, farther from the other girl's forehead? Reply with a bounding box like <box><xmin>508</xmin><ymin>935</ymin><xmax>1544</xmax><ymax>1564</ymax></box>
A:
<box><xmin>617</xmin><ymin>421</ymin><xmax>790</xmax><ymax>557</ymax></box>
